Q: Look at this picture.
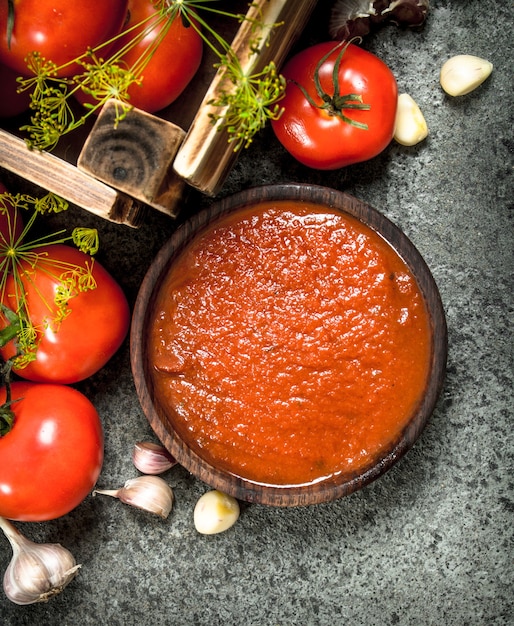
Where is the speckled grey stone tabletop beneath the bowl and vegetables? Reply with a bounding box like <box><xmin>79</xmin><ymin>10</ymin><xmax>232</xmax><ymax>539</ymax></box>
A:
<box><xmin>0</xmin><ymin>0</ymin><xmax>514</xmax><ymax>626</ymax></box>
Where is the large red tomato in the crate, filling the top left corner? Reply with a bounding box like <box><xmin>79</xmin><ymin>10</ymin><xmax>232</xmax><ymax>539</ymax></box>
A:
<box><xmin>0</xmin><ymin>0</ymin><xmax>128</xmax><ymax>76</ymax></box>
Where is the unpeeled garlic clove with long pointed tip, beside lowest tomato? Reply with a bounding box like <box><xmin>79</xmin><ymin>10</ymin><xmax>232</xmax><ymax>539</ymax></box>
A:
<box><xmin>93</xmin><ymin>476</ymin><xmax>173</xmax><ymax>519</ymax></box>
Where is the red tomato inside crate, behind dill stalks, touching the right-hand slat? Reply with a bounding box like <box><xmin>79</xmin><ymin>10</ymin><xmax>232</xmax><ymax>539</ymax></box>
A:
<box><xmin>77</xmin><ymin>0</ymin><xmax>203</xmax><ymax>113</ymax></box>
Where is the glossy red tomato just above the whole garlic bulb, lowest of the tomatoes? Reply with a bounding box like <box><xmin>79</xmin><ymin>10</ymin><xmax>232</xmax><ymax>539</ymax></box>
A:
<box><xmin>0</xmin><ymin>382</ymin><xmax>103</xmax><ymax>522</ymax></box>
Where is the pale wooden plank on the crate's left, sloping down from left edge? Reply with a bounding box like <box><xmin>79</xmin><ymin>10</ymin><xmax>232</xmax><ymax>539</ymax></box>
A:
<box><xmin>0</xmin><ymin>129</ymin><xmax>145</xmax><ymax>227</ymax></box>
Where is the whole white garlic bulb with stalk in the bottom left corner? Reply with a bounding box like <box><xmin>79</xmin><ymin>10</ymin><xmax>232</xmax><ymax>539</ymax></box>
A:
<box><xmin>0</xmin><ymin>517</ymin><xmax>81</xmax><ymax>604</ymax></box>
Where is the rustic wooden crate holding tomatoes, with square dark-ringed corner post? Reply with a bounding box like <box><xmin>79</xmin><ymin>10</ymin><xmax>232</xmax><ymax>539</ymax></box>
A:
<box><xmin>0</xmin><ymin>0</ymin><xmax>316</xmax><ymax>227</ymax></box>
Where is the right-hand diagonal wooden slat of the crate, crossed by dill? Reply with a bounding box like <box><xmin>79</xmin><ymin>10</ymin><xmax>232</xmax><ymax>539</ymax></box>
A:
<box><xmin>173</xmin><ymin>0</ymin><xmax>316</xmax><ymax>195</ymax></box>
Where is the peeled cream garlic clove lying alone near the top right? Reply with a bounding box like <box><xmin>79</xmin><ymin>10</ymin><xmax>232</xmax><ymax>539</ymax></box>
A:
<box><xmin>439</xmin><ymin>54</ymin><xmax>493</xmax><ymax>96</ymax></box>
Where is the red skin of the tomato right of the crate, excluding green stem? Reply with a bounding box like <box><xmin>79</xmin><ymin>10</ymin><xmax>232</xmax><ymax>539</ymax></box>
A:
<box><xmin>272</xmin><ymin>42</ymin><xmax>398</xmax><ymax>170</ymax></box>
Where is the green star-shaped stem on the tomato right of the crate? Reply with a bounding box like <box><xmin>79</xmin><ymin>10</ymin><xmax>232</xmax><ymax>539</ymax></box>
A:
<box><xmin>290</xmin><ymin>42</ymin><xmax>371</xmax><ymax>130</ymax></box>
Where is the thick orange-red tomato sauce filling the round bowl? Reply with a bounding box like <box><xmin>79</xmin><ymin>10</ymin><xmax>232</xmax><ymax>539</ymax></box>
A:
<box><xmin>149</xmin><ymin>202</ymin><xmax>430</xmax><ymax>485</ymax></box>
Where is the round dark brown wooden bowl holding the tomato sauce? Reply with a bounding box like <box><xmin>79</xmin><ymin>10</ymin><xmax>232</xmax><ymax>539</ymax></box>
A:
<box><xmin>131</xmin><ymin>184</ymin><xmax>447</xmax><ymax>506</ymax></box>
